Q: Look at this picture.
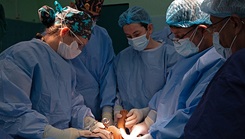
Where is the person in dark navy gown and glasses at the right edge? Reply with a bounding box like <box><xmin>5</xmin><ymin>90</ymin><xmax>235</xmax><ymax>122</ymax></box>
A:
<box><xmin>185</xmin><ymin>0</ymin><xmax>245</xmax><ymax>139</ymax></box>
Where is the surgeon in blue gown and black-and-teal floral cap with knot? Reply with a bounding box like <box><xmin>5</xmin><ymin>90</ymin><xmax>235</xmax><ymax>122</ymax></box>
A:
<box><xmin>0</xmin><ymin>2</ymin><xmax>110</xmax><ymax>139</ymax></box>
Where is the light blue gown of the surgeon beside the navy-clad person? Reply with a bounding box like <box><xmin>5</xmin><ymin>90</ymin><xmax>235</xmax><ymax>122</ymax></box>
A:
<box><xmin>149</xmin><ymin>47</ymin><xmax>225</xmax><ymax>139</ymax></box>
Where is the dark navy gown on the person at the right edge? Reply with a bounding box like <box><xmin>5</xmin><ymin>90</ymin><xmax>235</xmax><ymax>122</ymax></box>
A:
<box><xmin>185</xmin><ymin>48</ymin><xmax>245</xmax><ymax>139</ymax></box>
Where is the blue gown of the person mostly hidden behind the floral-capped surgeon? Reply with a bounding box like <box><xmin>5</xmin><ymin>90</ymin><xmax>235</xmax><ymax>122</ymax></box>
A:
<box><xmin>72</xmin><ymin>25</ymin><xmax>116</xmax><ymax>120</ymax></box>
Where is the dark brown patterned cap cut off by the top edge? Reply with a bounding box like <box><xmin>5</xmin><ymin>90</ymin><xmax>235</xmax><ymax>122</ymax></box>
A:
<box><xmin>75</xmin><ymin>0</ymin><xmax>104</xmax><ymax>17</ymax></box>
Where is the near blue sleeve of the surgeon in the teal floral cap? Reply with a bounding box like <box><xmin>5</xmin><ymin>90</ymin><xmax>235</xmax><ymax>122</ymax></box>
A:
<box><xmin>0</xmin><ymin>59</ymin><xmax>48</xmax><ymax>138</ymax></box>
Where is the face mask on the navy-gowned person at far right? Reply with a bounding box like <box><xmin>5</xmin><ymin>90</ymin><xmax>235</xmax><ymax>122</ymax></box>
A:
<box><xmin>213</xmin><ymin>18</ymin><xmax>234</xmax><ymax>59</ymax></box>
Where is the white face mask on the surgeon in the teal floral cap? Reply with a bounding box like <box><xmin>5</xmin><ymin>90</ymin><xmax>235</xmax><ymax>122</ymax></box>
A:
<box><xmin>57</xmin><ymin>41</ymin><xmax>82</xmax><ymax>59</ymax></box>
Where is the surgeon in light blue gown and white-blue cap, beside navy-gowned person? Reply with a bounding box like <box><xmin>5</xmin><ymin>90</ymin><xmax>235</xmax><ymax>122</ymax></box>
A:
<box><xmin>122</xmin><ymin>0</ymin><xmax>225</xmax><ymax>139</ymax></box>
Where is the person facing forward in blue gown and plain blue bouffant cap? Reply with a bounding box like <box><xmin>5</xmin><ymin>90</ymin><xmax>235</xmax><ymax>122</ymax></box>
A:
<box><xmin>114</xmin><ymin>6</ymin><xmax>181</xmax><ymax>128</ymax></box>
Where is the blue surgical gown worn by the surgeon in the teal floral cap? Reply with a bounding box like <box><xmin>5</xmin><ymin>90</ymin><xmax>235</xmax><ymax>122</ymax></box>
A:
<box><xmin>0</xmin><ymin>39</ymin><xmax>92</xmax><ymax>139</ymax></box>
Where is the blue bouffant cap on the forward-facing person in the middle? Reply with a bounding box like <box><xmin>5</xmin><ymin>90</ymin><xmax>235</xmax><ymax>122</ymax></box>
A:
<box><xmin>118</xmin><ymin>6</ymin><xmax>151</xmax><ymax>27</ymax></box>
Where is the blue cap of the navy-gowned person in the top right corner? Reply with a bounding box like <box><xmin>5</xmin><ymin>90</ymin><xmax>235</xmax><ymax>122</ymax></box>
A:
<box><xmin>201</xmin><ymin>0</ymin><xmax>245</xmax><ymax>18</ymax></box>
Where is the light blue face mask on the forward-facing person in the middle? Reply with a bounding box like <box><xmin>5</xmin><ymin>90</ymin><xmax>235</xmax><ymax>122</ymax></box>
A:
<box><xmin>128</xmin><ymin>34</ymin><xmax>149</xmax><ymax>51</ymax></box>
